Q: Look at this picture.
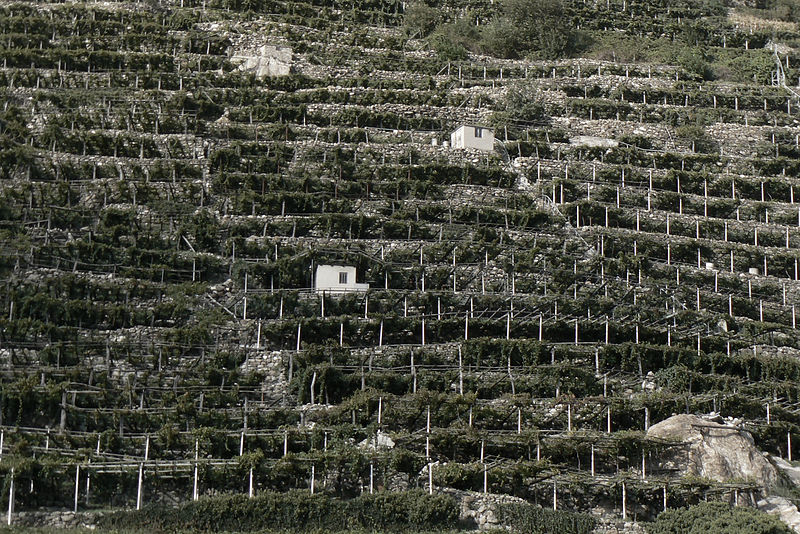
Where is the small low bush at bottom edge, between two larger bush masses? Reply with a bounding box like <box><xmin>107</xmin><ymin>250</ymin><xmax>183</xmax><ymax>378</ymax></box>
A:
<box><xmin>497</xmin><ymin>503</ymin><xmax>597</xmax><ymax>534</ymax></box>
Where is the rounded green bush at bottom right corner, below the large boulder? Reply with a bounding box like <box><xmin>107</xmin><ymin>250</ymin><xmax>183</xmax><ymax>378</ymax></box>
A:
<box><xmin>646</xmin><ymin>502</ymin><xmax>792</xmax><ymax>534</ymax></box>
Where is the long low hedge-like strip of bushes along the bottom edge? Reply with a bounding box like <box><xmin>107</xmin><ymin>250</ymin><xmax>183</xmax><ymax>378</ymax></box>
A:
<box><xmin>101</xmin><ymin>491</ymin><xmax>458</xmax><ymax>532</ymax></box>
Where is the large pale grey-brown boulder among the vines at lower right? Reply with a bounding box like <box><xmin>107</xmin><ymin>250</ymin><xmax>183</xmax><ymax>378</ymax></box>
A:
<box><xmin>647</xmin><ymin>414</ymin><xmax>780</xmax><ymax>488</ymax></box>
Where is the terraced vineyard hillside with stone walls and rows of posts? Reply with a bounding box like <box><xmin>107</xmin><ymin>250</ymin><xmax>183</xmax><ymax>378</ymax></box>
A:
<box><xmin>0</xmin><ymin>0</ymin><xmax>800</xmax><ymax>532</ymax></box>
